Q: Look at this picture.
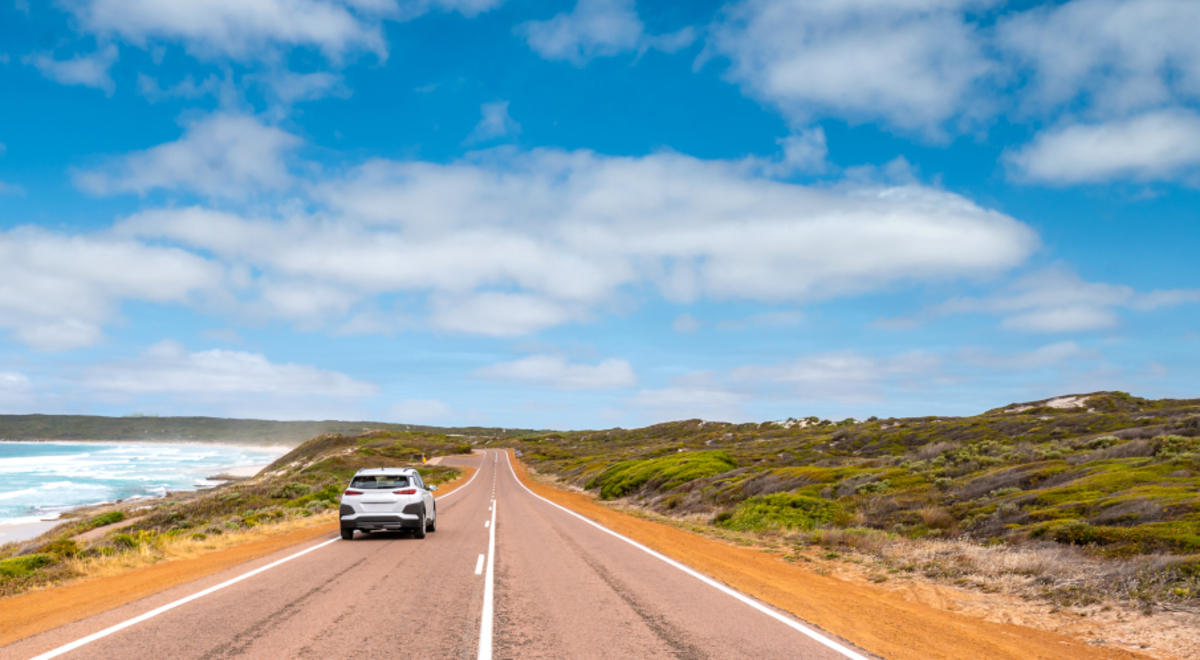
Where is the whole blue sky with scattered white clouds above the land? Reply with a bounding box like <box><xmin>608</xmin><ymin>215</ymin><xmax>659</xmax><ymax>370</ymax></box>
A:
<box><xmin>0</xmin><ymin>0</ymin><xmax>1200</xmax><ymax>428</ymax></box>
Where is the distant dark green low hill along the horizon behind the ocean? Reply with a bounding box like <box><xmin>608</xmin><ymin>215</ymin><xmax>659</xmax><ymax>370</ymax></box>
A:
<box><xmin>0</xmin><ymin>415</ymin><xmax>529</xmax><ymax>445</ymax></box>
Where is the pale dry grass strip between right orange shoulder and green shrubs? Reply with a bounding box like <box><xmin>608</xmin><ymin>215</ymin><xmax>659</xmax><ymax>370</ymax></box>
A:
<box><xmin>592</xmin><ymin>499</ymin><xmax>1200</xmax><ymax>660</ymax></box>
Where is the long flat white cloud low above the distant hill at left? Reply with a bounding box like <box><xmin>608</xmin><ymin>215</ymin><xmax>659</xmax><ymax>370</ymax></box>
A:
<box><xmin>82</xmin><ymin>341</ymin><xmax>378</xmax><ymax>400</ymax></box>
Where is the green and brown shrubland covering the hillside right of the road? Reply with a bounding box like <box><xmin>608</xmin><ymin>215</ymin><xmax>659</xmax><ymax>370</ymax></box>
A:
<box><xmin>514</xmin><ymin>392</ymin><xmax>1200</xmax><ymax>557</ymax></box>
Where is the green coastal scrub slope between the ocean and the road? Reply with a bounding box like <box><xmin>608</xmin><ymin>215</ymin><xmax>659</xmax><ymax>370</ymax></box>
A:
<box><xmin>0</xmin><ymin>431</ymin><xmax>477</xmax><ymax>596</ymax></box>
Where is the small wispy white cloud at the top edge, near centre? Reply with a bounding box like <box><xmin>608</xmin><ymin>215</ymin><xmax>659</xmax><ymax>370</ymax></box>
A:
<box><xmin>516</xmin><ymin>0</ymin><xmax>696</xmax><ymax>66</ymax></box>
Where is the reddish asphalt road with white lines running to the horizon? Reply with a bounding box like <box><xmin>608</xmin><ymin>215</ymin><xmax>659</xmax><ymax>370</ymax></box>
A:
<box><xmin>0</xmin><ymin>451</ymin><xmax>868</xmax><ymax>660</ymax></box>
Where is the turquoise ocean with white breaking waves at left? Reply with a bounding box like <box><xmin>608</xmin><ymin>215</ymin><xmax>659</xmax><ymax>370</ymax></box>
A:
<box><xmin>0</xmin><ymin>442</ymin><xmax>288</xmax><ymax>536</ymax></box>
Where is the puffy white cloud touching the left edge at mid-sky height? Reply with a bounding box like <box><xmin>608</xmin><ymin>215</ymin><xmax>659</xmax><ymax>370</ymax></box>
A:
<box><xmin>0</xmin><ymin>228</ymin><xmax>223</xmax><ymax>350</ymax></box>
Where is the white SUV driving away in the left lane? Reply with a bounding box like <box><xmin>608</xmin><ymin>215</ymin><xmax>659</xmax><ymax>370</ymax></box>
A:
<box><xmin>338</xmin><ymin>468</ymin><xmax>438</xmax><ymax>541</ymax></box>
